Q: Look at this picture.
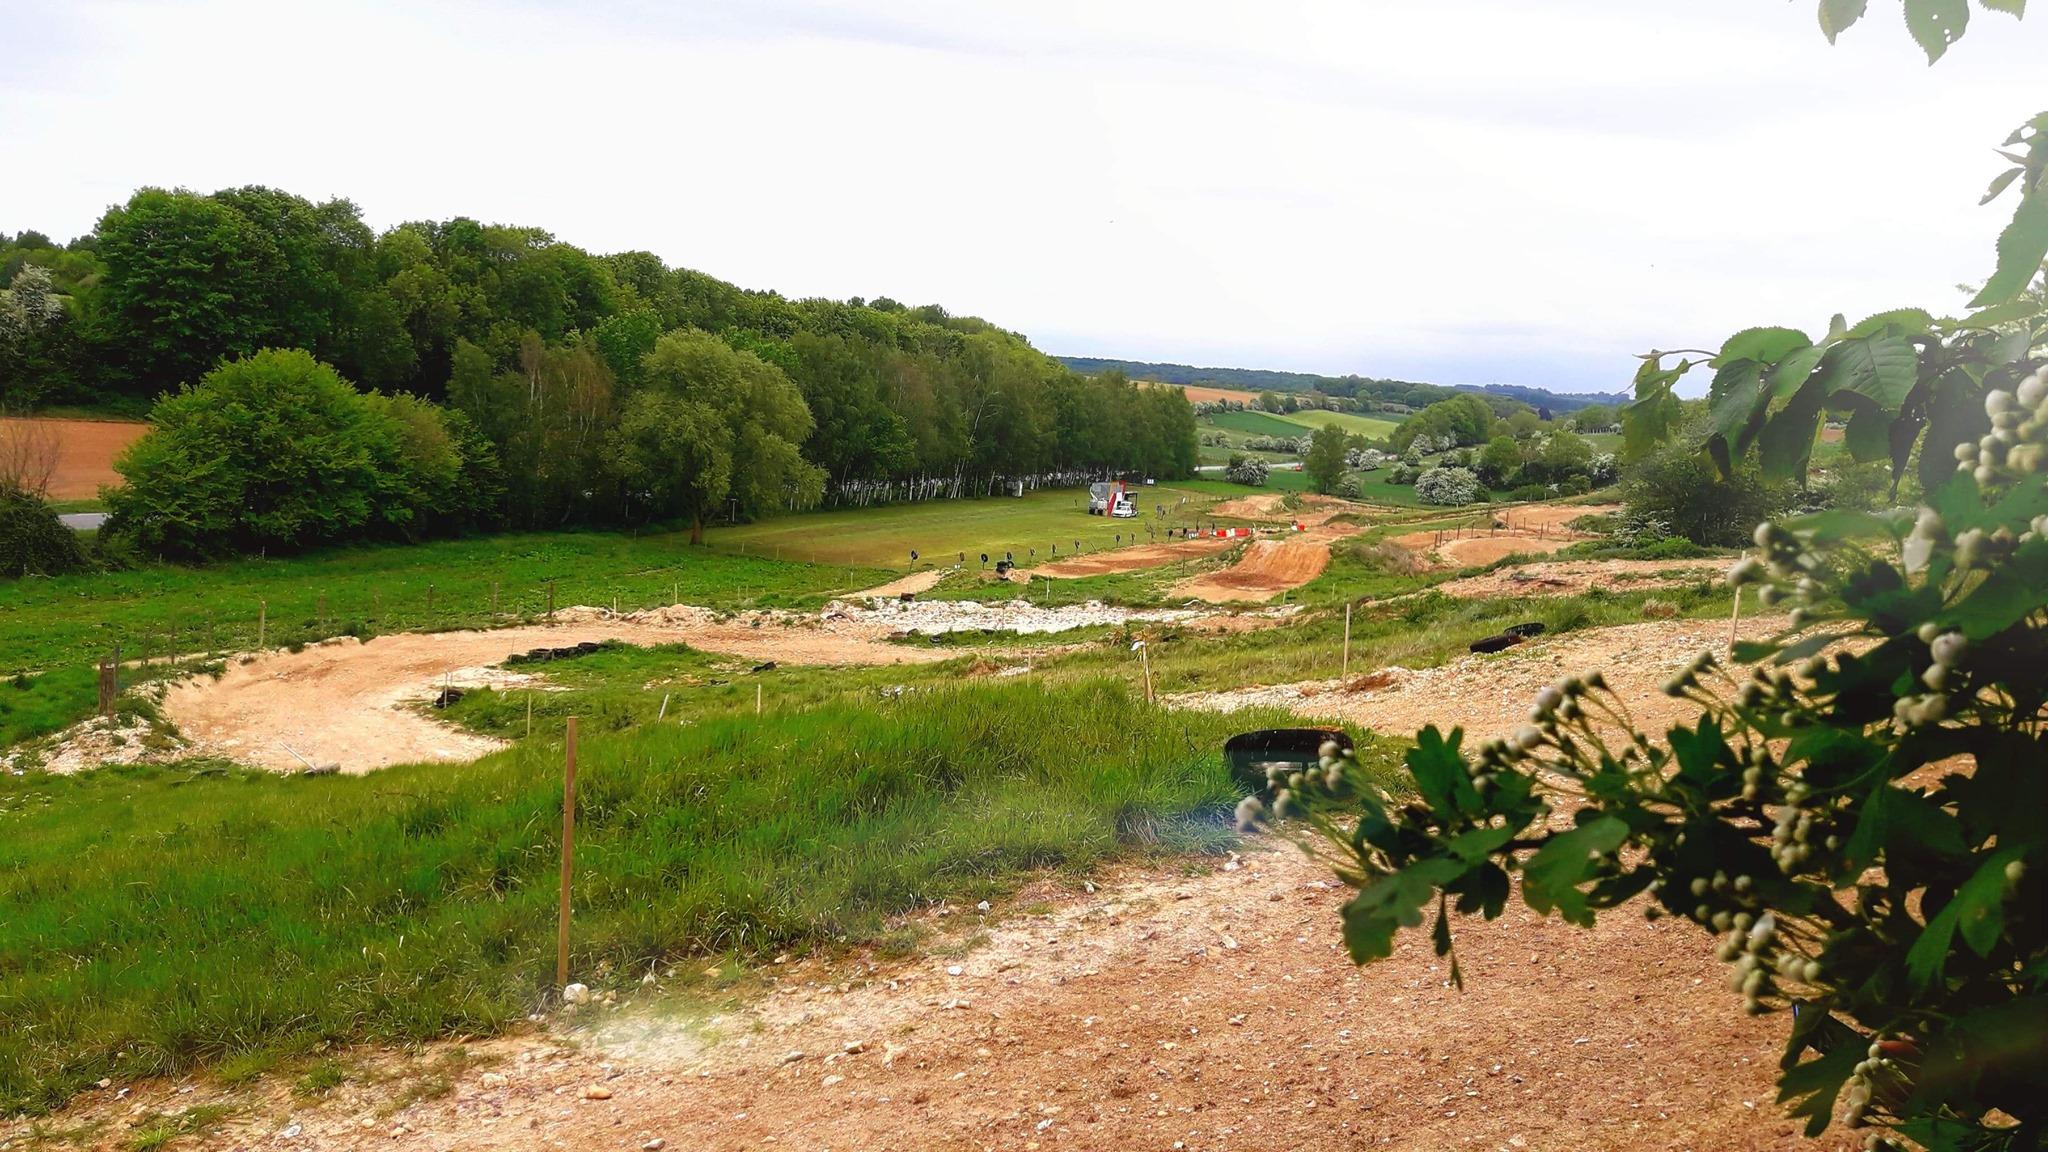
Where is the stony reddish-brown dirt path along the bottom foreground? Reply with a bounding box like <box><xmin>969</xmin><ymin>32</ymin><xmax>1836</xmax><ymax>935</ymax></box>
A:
<box><xmin>32</xmin><ymin>840</ymin><xmax>1818</xmax><ymax>1152</ymax></box>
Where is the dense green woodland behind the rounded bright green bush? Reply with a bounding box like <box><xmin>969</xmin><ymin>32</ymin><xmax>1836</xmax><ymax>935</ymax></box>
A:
<box><xmin>0</xmin><ymin>187</ymin><xmax>1196</xmax><ymax>557</ymax></box>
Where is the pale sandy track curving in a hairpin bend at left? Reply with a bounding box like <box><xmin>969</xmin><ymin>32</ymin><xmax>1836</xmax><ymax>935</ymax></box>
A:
<box><xmin>164</xmin><ymin>609</ymin><xmax>954</xmax><ymax>773</ymax></box>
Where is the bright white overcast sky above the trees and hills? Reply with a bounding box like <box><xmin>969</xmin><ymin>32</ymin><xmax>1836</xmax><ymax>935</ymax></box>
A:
<box><xmin>0</xmin><ymin>0</ymin><xmax>2048</xmax><ymax>389</ymax></box>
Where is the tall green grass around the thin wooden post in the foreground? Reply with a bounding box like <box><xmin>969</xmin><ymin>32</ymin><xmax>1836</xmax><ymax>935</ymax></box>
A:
<box><xmin>0</xmin><ymin>681</ymin><xmax>1280</xmax><ymax>1113</ymax></box>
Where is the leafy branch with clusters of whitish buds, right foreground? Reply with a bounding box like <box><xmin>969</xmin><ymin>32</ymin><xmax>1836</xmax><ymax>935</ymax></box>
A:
<box><xmin>1239</xmin><ymin>367</ymin><xmax>2048</xmax><ymax>1152</ymax></box>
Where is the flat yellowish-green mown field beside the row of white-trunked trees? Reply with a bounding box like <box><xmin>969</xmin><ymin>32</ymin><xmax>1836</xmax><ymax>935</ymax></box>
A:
<box><xmin>711</xmin><ymin>482</ymin><xmax>1212</xmax><ymax>572</ymax></box>
